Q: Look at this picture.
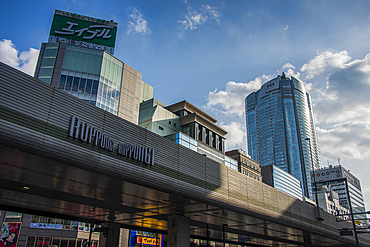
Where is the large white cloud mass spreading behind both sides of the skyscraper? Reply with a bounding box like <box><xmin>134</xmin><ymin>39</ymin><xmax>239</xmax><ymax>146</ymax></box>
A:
<box><xmin>205</xmin><ymin>50</ymin><xmax>370</xmax><ymax>210</ymax></box>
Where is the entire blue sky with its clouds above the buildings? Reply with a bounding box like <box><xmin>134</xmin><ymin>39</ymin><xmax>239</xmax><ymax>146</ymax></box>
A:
<box><xmin>0</xmin><ymin>0</ymin><xmax>370</xmax><ymax>209</ymax></box>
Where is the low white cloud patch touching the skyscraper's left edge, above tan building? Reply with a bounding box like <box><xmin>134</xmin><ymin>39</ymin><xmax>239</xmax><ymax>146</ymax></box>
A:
<box><xmin>220</xmin><ymin>121</ymin><xmax>246</xmax><ymax>150</ymax></box>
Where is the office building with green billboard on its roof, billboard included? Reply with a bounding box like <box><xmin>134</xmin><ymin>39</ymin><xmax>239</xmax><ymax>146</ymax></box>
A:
<box><xmin>35</xmin><ymin>10</ymin><xmax>152</xmax><ymax>124</ymax></box>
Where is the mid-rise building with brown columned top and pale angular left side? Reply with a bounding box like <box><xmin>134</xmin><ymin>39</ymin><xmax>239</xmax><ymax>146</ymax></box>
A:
<box><xmin>139</xmin><ymin>98</ymin><xmax>238</xmax><ymax>170</ymax></box>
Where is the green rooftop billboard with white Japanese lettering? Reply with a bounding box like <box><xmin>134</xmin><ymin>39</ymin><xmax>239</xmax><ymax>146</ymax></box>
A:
<box><xmin>50</xmin><ymin>10</ymin><xmax>117</xmax><ymax>47</ymax></box>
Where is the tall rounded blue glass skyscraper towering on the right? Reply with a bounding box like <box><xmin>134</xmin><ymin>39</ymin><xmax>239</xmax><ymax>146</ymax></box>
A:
<box><xmin>245</xmin><ymin>73</ymin><xmax>320</xmax><ymax>199</ymax></box>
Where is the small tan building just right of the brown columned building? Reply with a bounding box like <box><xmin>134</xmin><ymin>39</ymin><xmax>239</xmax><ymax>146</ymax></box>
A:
<box><xmin>225</xmin><ymin>149</ymin><xmax>262</xmax><ymax>181</ymax></box>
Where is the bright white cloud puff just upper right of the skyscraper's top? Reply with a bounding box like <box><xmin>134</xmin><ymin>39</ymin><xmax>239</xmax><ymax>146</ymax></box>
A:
<box><xmin>300</xmin><ymin>50</ymin><xmax>351</xmax><ymax>79</ymax></box>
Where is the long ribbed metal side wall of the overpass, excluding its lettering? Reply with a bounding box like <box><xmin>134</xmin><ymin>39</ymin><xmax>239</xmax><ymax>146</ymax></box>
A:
<box><xmin>0</xmin><ymin>63</ymin><xmax>369</xmax><ymax>243</ymax></box>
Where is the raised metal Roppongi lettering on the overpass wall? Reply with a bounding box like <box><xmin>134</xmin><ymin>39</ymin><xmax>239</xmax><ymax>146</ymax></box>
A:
<box><xmin>69</xmin><ymin>116</ymin><xmax>154</xmax><ymax>165</ymax></box>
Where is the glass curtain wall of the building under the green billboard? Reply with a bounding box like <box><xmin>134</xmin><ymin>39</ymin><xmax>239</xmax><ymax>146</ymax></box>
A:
<box><xmin>58</xmin><ymin>45</ymin><xmax>123</xmax><ymax>115</ymax></box>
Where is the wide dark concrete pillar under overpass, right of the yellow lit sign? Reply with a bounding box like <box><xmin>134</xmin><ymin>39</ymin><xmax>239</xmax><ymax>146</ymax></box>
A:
<box><xmin>167</xmin><ymin>215</ymin><xmax>190</xmax><ymax>247</ymax></box>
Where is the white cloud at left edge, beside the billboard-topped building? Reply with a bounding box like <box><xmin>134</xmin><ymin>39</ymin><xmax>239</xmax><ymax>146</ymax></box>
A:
<box><xmin>0</xmin><ymin>39</ymin><xmax>39</xmax><ymax>76</ymax></box>
